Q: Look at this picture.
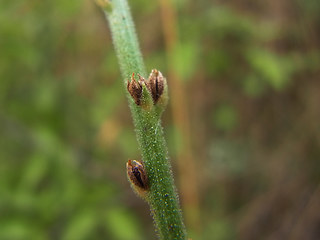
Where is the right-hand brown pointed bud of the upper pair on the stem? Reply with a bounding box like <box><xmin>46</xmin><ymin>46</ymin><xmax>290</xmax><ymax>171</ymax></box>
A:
<box><xmin>146</xmin><ymin>69</ymin><xmax>166</xmax><ymax>104</ymax></box>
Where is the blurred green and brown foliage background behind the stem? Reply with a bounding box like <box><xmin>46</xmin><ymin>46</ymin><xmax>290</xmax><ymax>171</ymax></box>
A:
<box><xmin>0</xmin><ymin>0</ymin><xmax>320</xmax><ymax>240</ymax></box>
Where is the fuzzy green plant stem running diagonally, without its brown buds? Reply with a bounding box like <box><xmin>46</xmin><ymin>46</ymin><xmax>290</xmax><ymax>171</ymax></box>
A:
<box><xmin>104</xmin><ymin>0</ymin><xmax>186</xmax><ymax>240</ymax></box>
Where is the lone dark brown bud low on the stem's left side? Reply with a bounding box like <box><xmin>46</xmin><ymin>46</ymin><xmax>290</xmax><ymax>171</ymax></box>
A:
<box><xmin>127</xmin><ymin>160</ymin><xmax>149</xmax><ymax>198</ymax></box>
